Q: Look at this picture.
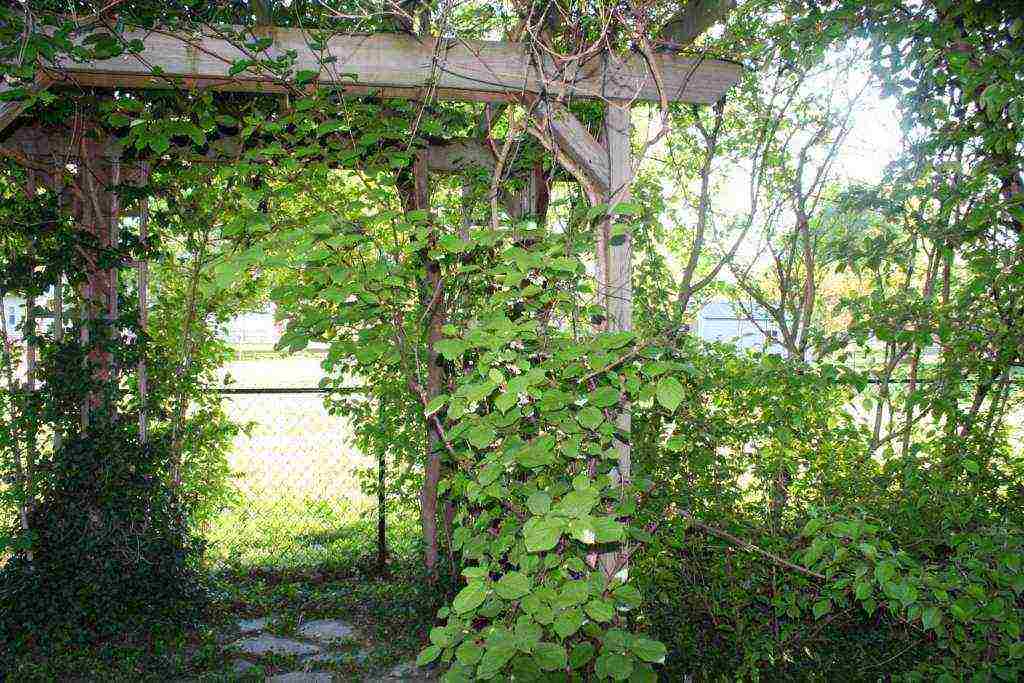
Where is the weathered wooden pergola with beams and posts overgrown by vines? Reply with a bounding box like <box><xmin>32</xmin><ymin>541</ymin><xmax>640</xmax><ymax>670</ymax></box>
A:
<box><xmin>0</xmin><ymin>17</ymin><xmax>741</xmax><ymax>573</ymax></box>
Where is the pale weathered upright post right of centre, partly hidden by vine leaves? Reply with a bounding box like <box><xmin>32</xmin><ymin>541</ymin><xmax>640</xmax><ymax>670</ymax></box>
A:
<box><xmin>597</xmin><ymin>102</ymin><xmax>633</xmax><ymax>579</ymax></box>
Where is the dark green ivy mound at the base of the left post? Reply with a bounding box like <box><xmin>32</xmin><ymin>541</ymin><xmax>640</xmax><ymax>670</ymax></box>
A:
<box><xmin>0</xmin><ymin>420</ymin><xmax>207</xmax><ymax>649</ymax></box>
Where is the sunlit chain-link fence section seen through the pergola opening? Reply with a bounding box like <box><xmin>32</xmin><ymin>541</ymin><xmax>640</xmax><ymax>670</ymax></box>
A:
<box><xmin>206</xmin><ymin>356</ymin><xmax>391</xmax><ymax>567</ymax></box>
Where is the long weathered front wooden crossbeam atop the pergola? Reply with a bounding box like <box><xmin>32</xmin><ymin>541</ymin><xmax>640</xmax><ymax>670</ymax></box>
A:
<box><xmin>34</xmin><ymin>27</ymin><xmax>741</xmax><ymax>103</ymax></box>
